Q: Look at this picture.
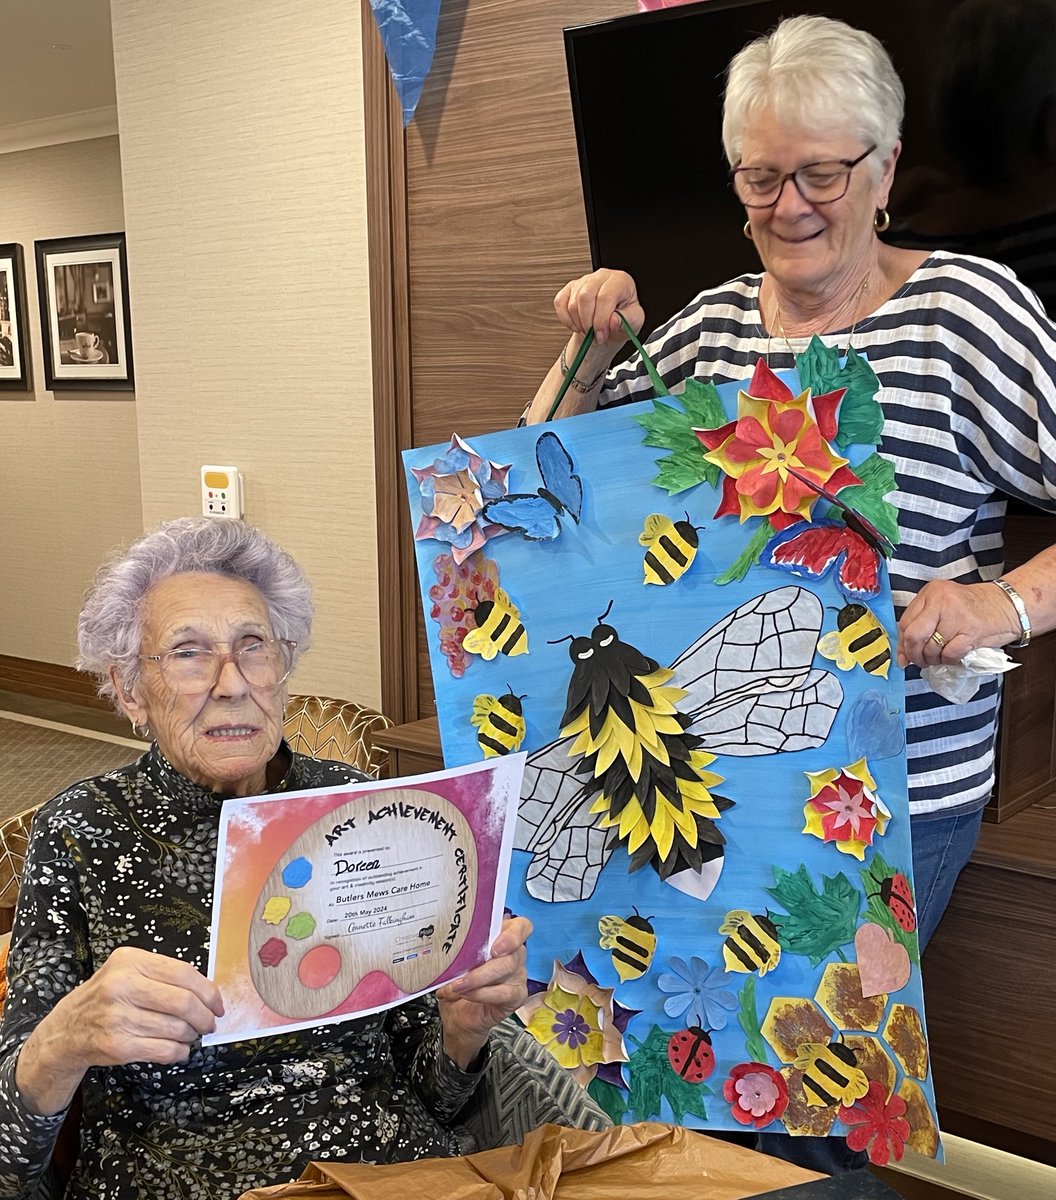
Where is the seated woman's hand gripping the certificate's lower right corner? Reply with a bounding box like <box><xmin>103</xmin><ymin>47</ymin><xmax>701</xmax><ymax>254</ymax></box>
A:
<box><xmin>437</xmin><ymin>917</ymin><xmax>532</xmax><ymax>1070</ymax></box>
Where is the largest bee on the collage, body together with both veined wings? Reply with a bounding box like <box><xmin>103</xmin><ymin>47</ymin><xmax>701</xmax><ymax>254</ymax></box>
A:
<box><xmin>514</xmin><ymin>586</ymin><xmax>844</xmax><ymax>904</ymax></box>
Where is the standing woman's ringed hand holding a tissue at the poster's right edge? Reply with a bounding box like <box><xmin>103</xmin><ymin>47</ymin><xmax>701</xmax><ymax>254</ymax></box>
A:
<box><xmin>898</xmin><ymin>580</ymin><xmax>1020</xmax><ymax>667</ymax></box>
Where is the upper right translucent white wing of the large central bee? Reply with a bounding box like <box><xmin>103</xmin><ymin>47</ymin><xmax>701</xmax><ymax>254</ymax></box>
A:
<box><xmin>671</xmin><ymin>586</ymin><xmax>844</xmax><ymax>755</ymax></box>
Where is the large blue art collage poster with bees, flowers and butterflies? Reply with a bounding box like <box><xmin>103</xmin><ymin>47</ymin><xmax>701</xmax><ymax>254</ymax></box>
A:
<box><xmin>404</xmin><ymin>341</ymin><xmax>941</xmax><ymax>1163</ymax></box>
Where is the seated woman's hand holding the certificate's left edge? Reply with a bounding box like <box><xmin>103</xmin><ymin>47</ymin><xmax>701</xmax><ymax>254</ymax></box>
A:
<box><xmin>16</xmin><ymin>946</ymin><xmax>223</xmax><ymax>1115</ymax></box>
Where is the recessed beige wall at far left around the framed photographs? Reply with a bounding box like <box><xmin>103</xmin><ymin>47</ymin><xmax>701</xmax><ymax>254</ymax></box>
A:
<box><xmin>0</xmin><ymin>138</ymin><xmax>142</xmax><ymax>666</ymax></box>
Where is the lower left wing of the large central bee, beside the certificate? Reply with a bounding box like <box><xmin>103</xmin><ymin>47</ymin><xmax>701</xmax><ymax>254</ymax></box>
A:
<box><xmin>514</xmin><ymin>738</ymin><xmax>611</xmax><ymax>902</ymax></box>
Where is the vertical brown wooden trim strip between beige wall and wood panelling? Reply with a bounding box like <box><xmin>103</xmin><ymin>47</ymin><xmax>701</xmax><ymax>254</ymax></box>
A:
<box><xmin>361</xmin><ymin>0</ymin><xmax>420</xmax><ymax>724</ymax></box>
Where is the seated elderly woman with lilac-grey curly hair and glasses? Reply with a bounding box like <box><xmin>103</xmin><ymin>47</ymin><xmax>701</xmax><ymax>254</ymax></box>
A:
<box><xmin>0</xmin><ymin>518</ymin><xmax>530</xmax><ymax>1200</ymax></box>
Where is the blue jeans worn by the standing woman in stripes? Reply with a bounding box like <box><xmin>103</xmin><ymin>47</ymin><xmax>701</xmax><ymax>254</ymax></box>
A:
<box><xmin>756</xmin><ymin>809</ymin><xmax>983</xmax><ymax>1175</ymax></box>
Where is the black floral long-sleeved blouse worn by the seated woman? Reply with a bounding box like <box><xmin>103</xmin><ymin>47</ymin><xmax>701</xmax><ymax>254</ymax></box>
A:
<box><xmin>0</xmin><ymin>744</ymin><xmax>482</xmax><ymax>1200</ymax></box>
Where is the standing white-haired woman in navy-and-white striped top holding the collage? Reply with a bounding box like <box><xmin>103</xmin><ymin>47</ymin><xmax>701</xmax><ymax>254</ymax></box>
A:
<box><xmin>527</xmin><ymin>9</ymin><xmax>1056</xmax><ymax>1161</ymax></box>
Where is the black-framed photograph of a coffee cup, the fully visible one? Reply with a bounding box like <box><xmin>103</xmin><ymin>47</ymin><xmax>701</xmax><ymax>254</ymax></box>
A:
<box><xmin>36</xmin><ymin>233</ymin><xmax>136</xmax><ymax>391</ymax></box>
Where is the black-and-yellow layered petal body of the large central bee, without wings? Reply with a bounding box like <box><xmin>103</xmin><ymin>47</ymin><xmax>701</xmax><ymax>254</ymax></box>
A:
<box><xmin>544</xmin><ymin>604</ymin><xmax>733</xmax><ymax>880</ymax></box>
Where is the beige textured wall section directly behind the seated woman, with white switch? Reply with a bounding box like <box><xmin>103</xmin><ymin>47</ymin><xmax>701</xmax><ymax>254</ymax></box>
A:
<box><xmin>112</xmin><ymin>0</ymin><xmax>380</xmax><ymax>704</ymax></box>
